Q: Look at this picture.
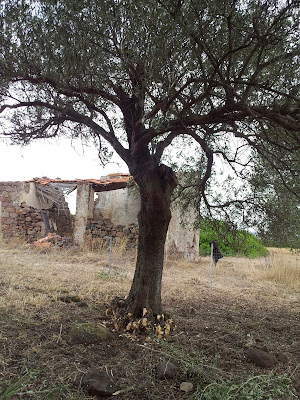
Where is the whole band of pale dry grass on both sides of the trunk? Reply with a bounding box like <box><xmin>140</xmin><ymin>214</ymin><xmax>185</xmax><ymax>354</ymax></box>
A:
<box><xmin>0</xmin><ymin>242</ymin><xmax>300</xmax><ymax>318</ymax></box>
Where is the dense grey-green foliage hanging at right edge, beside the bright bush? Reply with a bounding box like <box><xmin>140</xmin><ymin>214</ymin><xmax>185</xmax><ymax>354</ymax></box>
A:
<box><xmin>250</xmin><ymin>151</ymin><xmax>300</xmax><ymax>249</ymax></box>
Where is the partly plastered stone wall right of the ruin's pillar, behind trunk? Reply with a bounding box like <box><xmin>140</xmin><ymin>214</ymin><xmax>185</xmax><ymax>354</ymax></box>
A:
<box><xmin>86</xmin><ymin>189</ymin><xmax>199</xmax><ymax>261</ymax></box>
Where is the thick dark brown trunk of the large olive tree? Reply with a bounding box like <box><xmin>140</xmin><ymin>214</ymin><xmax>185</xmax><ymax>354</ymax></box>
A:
<box><xmin>126</xmin><ymin>165</ymin><xmax>177</xmax><ymax>317</ymax></box>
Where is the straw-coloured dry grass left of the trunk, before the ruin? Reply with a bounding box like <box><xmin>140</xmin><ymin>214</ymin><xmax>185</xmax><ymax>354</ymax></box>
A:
<box><xmin>1</xmin><ymin>250</ymin><xmax>127</xmax><ymax>308</ymax></box>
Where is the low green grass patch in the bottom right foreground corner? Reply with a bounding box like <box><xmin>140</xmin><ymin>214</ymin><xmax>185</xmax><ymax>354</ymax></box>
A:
<box><xmin>192</xmin><ymin>374</ymin><xmax>297</xmax><ymax>400</ymax></box>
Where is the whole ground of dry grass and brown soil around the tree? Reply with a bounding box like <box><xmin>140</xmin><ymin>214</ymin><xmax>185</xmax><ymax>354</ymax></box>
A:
<box><xmin>0</xmin><ymin>244</ymin><xmax>300</xmax><ymax>400</ymax></box>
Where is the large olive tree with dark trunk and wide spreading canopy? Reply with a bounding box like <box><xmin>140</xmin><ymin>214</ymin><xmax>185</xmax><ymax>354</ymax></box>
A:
<box><xmin>0</xmin><ymin>0</ymin><xmax>300</xmax><ymax>316</ymax></box>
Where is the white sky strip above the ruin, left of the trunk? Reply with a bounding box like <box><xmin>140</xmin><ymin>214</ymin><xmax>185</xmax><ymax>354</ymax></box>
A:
<box><xmin>0</xmin><ymin>139</ymin><xmax>128</xmax><ymax>181</ymax></box>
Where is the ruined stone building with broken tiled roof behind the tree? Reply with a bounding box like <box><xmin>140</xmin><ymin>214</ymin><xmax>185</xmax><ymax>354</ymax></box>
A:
<box><xmin>0</xmin><ymin>174</ymin><xmax>199</xmax><ymax>261</ymax></box>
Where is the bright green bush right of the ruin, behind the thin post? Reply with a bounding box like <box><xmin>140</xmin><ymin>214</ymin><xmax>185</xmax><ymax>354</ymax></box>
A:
<box><xmin>199</xmin><ymin>220</ymin><xmax>268</xmax><ymax>257</ymax></box>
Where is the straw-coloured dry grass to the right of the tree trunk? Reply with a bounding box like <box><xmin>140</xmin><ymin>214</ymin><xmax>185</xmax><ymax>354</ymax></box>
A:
<box><xmin>164</xmin><ymin>249</ymin><xmax>300</xmax><ymax>303</ymax></box>
